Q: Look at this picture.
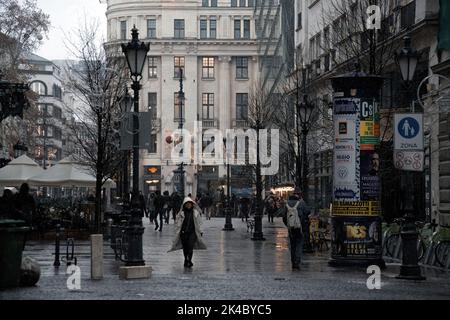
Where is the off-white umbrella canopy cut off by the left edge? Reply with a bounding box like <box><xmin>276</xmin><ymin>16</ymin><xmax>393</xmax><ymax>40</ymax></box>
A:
<box><xmin>0</xmin><ymin>155</ymin><xmax>44</xmax><ymax>187</ymax></box>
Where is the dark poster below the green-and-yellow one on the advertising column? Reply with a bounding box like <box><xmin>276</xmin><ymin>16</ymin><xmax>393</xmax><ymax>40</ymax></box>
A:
<box><xmin>360</xmin><ymin>150</ymin><xmax>380</xmax><ymax>201</ymax></box>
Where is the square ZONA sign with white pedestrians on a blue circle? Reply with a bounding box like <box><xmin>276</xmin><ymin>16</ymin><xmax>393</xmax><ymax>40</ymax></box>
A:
<box><xmin>394</xmin><ymin>113</ymin><xmax>423</xmax><ymax>151</ymax></box>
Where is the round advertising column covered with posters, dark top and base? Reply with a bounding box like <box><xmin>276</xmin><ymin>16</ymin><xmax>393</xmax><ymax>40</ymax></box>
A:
<box><xmin>330</xmin><ymin>73</ymin><xmax>384</xmax><ymax>267</ymax></box>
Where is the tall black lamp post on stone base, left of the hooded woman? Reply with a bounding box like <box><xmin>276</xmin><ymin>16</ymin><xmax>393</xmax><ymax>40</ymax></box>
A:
<box><xmin>122</xmin><ymin>26</ymin><xmax>150</xmax><ymax>266</ymax></box>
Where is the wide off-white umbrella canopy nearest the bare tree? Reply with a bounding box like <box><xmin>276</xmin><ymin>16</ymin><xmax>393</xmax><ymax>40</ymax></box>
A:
<box><xmin>28</xmin><ymin>158</ymin><xmax>114</xmax><ymax>188</ymax></box>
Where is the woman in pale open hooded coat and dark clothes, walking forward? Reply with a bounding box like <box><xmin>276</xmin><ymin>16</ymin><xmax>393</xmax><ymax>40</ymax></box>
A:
<box><xmin>169</xmin><ymin>197</ymin><xmax>206</xmax><ymax>268</ymax></box>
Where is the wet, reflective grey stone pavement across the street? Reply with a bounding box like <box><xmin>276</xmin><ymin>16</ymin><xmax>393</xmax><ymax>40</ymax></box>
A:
<box><xmin>0</xmin><ymin>218</ymin><xmax>450</xmax><ymax>300</ymax></box>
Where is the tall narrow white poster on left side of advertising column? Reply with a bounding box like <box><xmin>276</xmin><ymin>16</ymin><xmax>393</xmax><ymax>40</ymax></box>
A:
<box><xmin>333</xmin><ymin>114</ymin><xmax>359</xmax><ymax>201</ymax></box>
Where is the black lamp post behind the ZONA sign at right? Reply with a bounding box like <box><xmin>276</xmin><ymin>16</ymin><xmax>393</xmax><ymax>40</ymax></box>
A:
<box><xmin>396</xmin><ymin>36</ymin><xmax>425</xmax><ymax>280</ymax></box>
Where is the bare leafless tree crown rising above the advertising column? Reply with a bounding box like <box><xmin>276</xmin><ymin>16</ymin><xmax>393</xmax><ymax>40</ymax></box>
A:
<box><xmin>318</xmin><ymin>0</ymin><xmax>400</xmax><ymax>75</ymax></box>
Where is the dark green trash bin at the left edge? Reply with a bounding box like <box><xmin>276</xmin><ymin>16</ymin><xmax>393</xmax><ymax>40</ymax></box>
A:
<box><xmin>0</xmin><ymin>220</ymin><xmax>30</xmax><ymax>288</ymax></box>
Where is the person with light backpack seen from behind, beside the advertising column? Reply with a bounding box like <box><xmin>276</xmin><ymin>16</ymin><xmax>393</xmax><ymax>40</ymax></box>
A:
<box><xmin>282</xmin><ymin>195</ymin><xmax>306</xmax><ymax>270</ymax></box>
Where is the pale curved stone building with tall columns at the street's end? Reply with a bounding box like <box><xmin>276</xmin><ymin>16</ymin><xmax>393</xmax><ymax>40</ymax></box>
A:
<box><xmin>105</xmin><ymin>0</ymin><xmax>259</xmax><ymax>195</ymax></box>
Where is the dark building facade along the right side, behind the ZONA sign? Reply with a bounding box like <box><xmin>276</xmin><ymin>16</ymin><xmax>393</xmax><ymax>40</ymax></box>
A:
<box><xmin>295</xmin><ymin>0</ymin><xmax>448</xmax><ymax>221</ymax></box>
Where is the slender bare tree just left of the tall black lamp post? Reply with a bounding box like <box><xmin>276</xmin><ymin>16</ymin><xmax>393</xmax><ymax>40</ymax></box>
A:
<box><xmin>62</xmin><ymin>22</ymin><xmax>127</xmax><ymax>228</ymax></box>
